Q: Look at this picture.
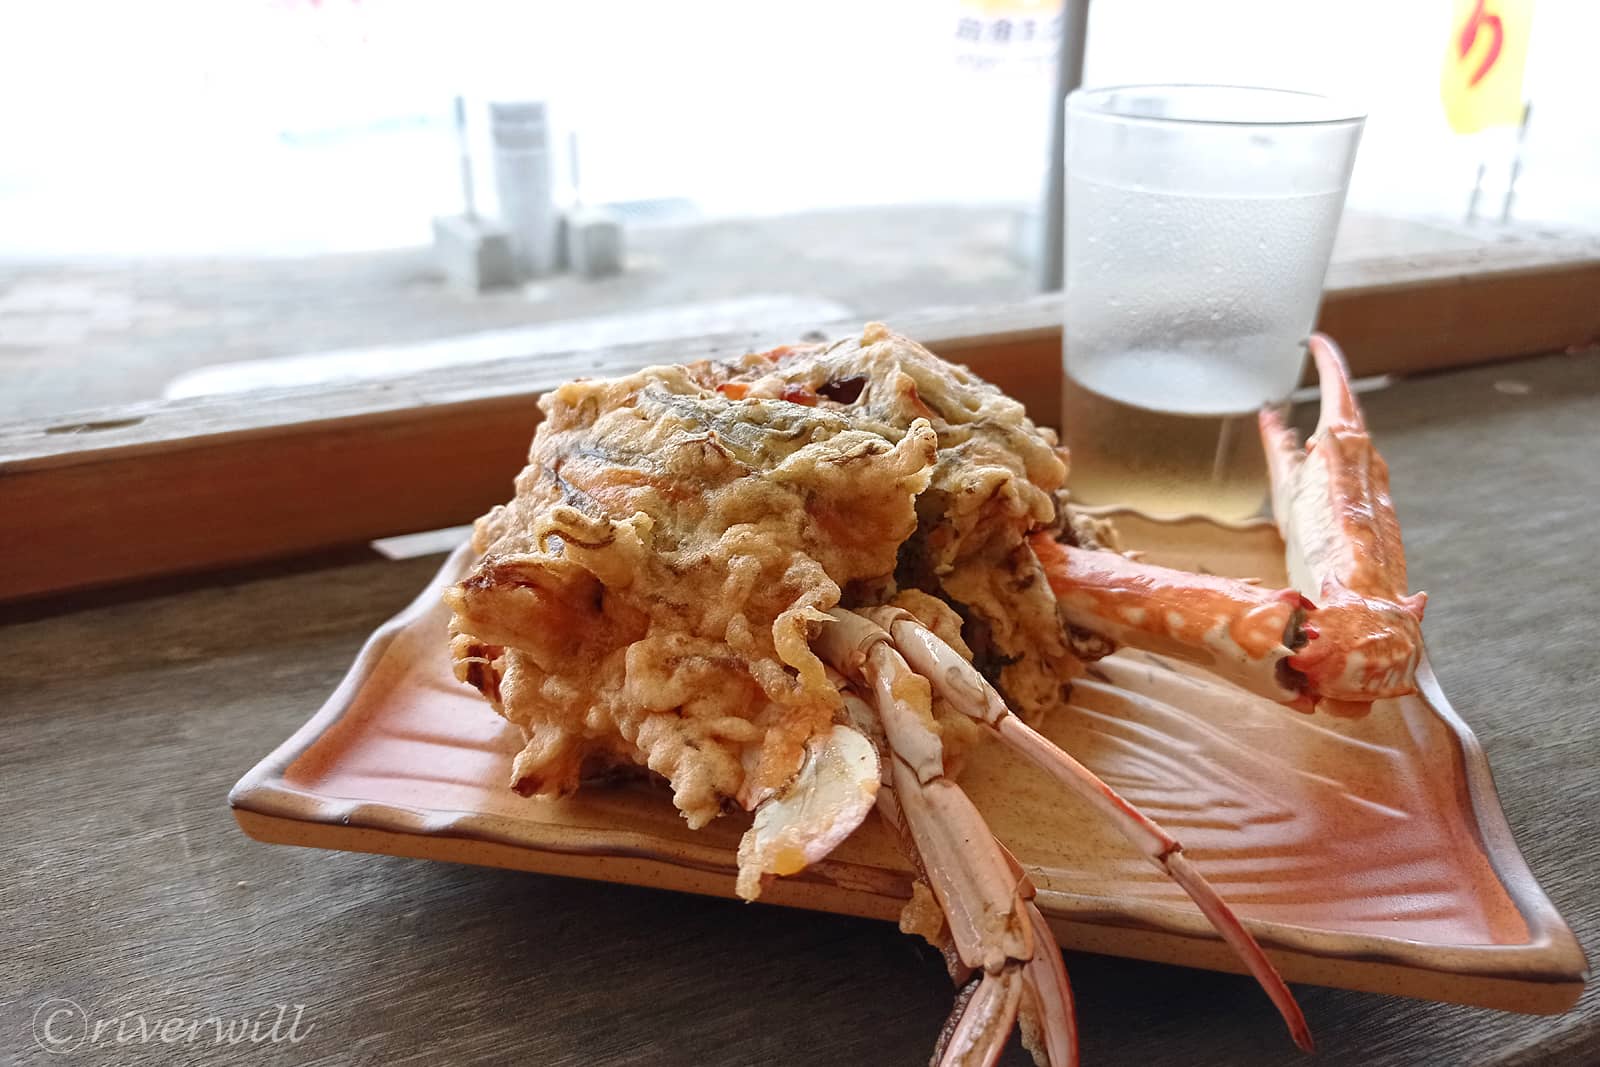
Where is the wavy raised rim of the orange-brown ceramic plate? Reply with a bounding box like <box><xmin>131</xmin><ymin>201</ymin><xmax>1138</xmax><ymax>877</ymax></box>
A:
<box><xmin>229</xmin><ymin>518</ymin><xmax>1589</xmax><ymax>1011</ymax></box>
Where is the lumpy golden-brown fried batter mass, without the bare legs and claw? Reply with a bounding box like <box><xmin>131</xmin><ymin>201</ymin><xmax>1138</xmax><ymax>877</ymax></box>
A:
<box><xmin>446</xmin><ymin>323</ymin><xmax>1078</xmax><ymax>825</ymax></box>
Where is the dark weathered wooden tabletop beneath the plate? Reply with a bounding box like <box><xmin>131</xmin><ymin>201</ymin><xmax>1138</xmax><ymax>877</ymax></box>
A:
<box><xmin>0</xmin><ymin>355</ymin><xmax>1600</xmax><ymax>1067</ymax></box>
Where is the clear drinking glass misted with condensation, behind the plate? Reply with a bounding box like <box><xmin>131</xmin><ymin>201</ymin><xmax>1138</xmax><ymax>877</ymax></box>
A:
<box><xmin>1061</xmin><ymin>85</ymin><xmax>1365</xmax><ymax>520</ymax></box>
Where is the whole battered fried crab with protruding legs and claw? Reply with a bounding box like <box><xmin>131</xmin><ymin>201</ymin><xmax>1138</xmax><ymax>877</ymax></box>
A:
<box><xmin>446</xmin><ymin>323</ymin><xmax>1422</xmax><ymax>1065</ymax></box>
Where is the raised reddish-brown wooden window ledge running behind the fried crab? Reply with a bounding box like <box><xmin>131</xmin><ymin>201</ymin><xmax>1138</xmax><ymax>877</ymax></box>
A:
<box><xmin>0</xmin><ymin>238</ymin><xmax>1600</xmax><ymax>600</ymax></box>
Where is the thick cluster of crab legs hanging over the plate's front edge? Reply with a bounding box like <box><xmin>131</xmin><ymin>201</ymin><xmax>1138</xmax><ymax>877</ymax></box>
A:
<box><xmin>816</xmin><ymin>609</ymin><xmax>1075</xmax><ymax>1067</ymax></box>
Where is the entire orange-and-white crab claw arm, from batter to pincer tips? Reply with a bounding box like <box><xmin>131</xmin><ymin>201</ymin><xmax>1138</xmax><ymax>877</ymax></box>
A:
<box><xmin>1029</xmin><ymin>334</ymin><xmax>1427</xmax><ymax>715</ymax></box>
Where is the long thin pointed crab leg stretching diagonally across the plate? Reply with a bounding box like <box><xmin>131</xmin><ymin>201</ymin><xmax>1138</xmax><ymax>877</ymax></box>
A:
<box><xmin>872</xmin><ymin>608</ymin><xmax>1312</xmax><ymax>1053</ymax></box>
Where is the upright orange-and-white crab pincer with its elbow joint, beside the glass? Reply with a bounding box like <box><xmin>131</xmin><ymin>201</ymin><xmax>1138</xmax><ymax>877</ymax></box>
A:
<box><xmin>1261</xmin><ymin>333</ymin><xmax>1427</xmax><ymax>713</ymax></box>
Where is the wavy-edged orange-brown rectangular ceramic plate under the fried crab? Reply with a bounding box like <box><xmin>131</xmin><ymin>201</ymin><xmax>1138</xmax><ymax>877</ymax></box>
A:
<box><xmin>230</xmin><ymin>512</ymin><xmax>1584</xmax><ymax>1013</ymax></box>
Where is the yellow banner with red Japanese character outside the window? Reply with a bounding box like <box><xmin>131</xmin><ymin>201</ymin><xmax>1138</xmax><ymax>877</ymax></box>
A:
<box><xmin>1440</xmin><ymin>0</ymin><xmax>1533</xmax><ymax>133</ymax></box>
